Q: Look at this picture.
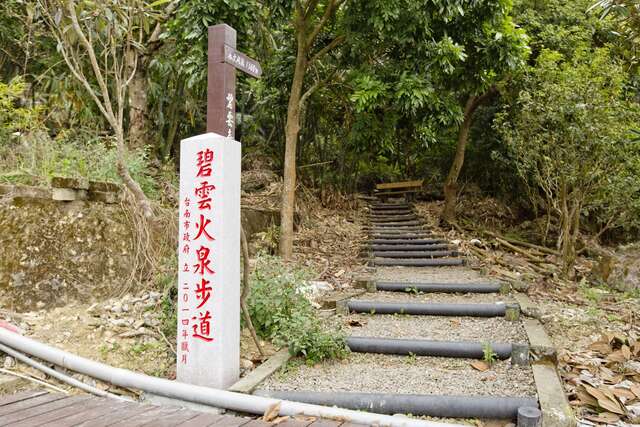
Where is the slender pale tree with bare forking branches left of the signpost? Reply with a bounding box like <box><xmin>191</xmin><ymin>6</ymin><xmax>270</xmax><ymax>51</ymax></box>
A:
<box><xmin>39</xmin><ymin>0</ymin><xmax>153</xmax><ymax>217</ymax></box>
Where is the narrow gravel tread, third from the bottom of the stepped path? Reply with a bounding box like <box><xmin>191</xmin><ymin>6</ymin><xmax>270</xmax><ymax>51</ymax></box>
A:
<box><xmin>353</xmin><ymin>292</ymin><xmax>515</xmax><ymax>304</ymax></box>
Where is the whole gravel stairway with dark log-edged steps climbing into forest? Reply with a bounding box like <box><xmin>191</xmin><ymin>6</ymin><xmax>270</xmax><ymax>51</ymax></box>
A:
<box><xmin>257</xmin><ymin>202</ymin><xmax>540</xmax><ymax>427</ymax></box>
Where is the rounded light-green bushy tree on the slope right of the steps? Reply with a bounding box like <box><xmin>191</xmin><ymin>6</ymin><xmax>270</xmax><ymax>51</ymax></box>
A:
<box><xmin>495</xmin><ymin>46</ymin><xmax>640</xmax><ymax>263</ymax></box>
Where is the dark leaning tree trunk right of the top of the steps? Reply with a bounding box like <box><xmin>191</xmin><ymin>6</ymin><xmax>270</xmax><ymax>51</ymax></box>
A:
<box><xmin>441</xmin><ymin>87</ymin><xmax>497</xmax><ymax>223</ymax></box>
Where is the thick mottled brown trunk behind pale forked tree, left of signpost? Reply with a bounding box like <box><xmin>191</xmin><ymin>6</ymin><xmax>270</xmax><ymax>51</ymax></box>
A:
<box><xmin>128</xmin><ymin>65</ymin><xmax>150</xmax><ymax>148</ymax></box>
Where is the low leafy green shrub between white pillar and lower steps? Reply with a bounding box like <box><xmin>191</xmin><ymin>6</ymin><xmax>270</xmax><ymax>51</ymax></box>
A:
<box><xmin>248</xmin><ymin>255</ymin><xmax>347</xmax><ymax>363</ymax></box>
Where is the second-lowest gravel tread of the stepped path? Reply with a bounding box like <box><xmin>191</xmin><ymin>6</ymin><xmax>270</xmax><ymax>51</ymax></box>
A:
<box><xmin>345</xmin><ymin>314</ymin><xmax>528</xmax><ymax>343</ymax></box>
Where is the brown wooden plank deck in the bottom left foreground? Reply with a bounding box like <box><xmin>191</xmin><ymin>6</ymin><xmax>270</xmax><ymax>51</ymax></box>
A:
<box><xmin>0</xmin><ymin>391</ymin><xmax>360</xmax><ymax>427</ymax></box>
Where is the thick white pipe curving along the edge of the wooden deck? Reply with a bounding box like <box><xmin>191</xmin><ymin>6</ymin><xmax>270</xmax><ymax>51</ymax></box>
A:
<box><xmin>0</xmin><ymin>327</ymin><xmax>462</xmax><ymax>427</ymax></box>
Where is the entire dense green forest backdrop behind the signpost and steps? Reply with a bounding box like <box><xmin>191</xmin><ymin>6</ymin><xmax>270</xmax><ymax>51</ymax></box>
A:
<box><xmin>0</xmin><ymin>0</ymin><xmax>640</xmax><ymax>273</ymax></box>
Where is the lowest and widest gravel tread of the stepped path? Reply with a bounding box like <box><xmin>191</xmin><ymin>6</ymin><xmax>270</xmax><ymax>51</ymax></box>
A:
<box><xmin>260</xmin><ymin>353</ymin><xmax>536</xmax><ymax>397</ymax></box>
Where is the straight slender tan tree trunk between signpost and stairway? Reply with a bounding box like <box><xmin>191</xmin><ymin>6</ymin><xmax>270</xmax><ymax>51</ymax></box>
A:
<box><xmin>280</xmin><ymin>34</ymin><xmax>307</xmax><ymax>260</ymax></box>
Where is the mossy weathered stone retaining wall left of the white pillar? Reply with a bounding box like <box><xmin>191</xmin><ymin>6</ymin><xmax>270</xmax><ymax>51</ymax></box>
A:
<box><xmin>0</xmin><ymin>178</ymin><xmax>133</xmax><ymax>311</ymax></box>
